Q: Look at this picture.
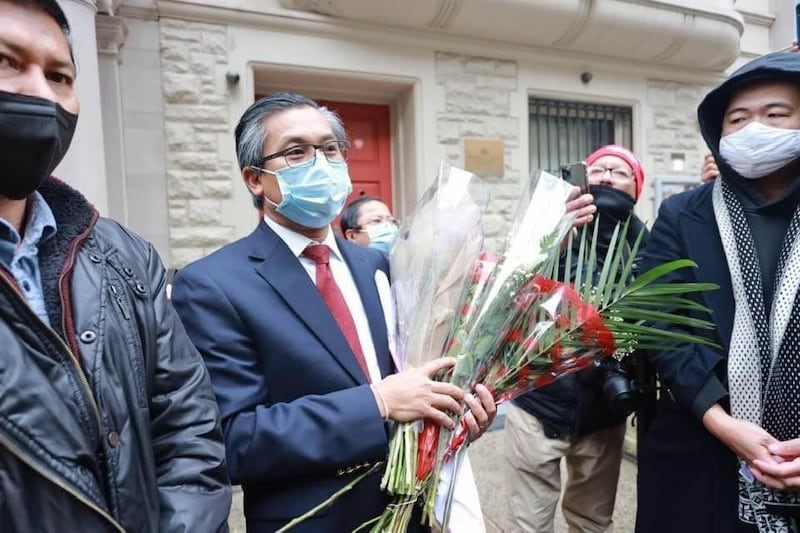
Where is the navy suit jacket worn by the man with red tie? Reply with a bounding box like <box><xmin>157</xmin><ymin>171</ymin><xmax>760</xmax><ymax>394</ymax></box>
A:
<box><xmin>172</xmin><ymin>221</ymin><xmax>400</xmax><ymax>532</ymax></box>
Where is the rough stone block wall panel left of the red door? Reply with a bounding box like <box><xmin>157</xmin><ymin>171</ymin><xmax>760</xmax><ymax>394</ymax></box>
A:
<box><xmin>159</xmin><ymin>19</ymin><xmax>235</xmax><ymax>267</ymax></box>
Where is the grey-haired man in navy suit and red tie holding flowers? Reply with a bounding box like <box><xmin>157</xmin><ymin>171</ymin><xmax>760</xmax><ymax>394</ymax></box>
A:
<box><xmin>172</xmin><ymin>93</ymin><xmax>495</xmax><ymax>532</ymax></box>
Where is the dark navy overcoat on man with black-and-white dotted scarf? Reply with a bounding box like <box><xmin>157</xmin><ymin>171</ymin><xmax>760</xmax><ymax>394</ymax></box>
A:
<box><xmin>636</xmin><ymin>183</ymin><xmax>740</xmax><ymax>533</ymax></box>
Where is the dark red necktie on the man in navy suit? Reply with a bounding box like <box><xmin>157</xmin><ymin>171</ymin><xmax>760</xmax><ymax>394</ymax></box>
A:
<box><xmin>303</xmin><ymin>244</ymin><xmax>372</xmax><ymax>381</ymax></box>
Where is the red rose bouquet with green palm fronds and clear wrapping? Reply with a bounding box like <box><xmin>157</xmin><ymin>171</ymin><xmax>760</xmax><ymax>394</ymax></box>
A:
<box><xmin>372</xmin><ymin>172</ymin><xmax>715</xmax><ymax>531</ymax></box>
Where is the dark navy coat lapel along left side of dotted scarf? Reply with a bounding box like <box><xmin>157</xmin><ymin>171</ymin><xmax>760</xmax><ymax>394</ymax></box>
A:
<box><xmin>681</xmin><ymin>194</ymin><xmax>734</xmax><ymax>352</ymax></box>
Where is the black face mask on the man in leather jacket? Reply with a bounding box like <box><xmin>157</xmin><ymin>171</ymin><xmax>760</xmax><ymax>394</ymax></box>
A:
<box><xmin>0</xmin><ymin>91</ymin><xmax>78</xmax><ymax>200</ymax></box>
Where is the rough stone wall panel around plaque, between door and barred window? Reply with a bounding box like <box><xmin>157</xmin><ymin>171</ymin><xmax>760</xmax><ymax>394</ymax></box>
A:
<box><xmin>436</xmin><ymin>52</ymin><xmax>520</xmax><ymax>251</ymax></box>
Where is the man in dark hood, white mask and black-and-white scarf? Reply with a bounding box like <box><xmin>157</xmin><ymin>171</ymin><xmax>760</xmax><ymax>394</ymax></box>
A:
<box><xmin>636</xmin><ymin>52</ymin><xmax>800</xmax><ymax>533</ymax></box>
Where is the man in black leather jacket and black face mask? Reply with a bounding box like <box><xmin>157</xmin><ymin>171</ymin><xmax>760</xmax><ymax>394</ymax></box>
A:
<box><xmin>0</xmin><ymin>0</ymin><xmax>230</xmax><ymax>533</ymax></box>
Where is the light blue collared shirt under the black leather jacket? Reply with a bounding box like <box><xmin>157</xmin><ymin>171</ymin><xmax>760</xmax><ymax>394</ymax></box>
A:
<box><xmin>0</xmin><ymin>192</ymin><xmax>56</xmax><ymax>324</ymax></box>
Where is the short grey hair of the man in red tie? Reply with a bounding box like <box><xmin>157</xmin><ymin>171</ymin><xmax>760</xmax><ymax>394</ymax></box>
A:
<box><xmin>234</xmin><ymin>92</ymin><xmax>347</xmax><ymax>209</ymax></box>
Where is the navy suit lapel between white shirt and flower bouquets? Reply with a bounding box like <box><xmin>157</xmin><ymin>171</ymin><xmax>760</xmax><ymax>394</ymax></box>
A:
<box><xmin>337</xmin><ymin>239</ymin><xmax>393</xmax><ymax>377</ymax></box>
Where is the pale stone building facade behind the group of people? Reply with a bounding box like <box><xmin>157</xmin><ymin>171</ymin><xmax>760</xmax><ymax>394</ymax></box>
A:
<box><xmin>57</xmin><ymin>0</ymin><xmax>793</xmax><ymax>267</ymax></box>
